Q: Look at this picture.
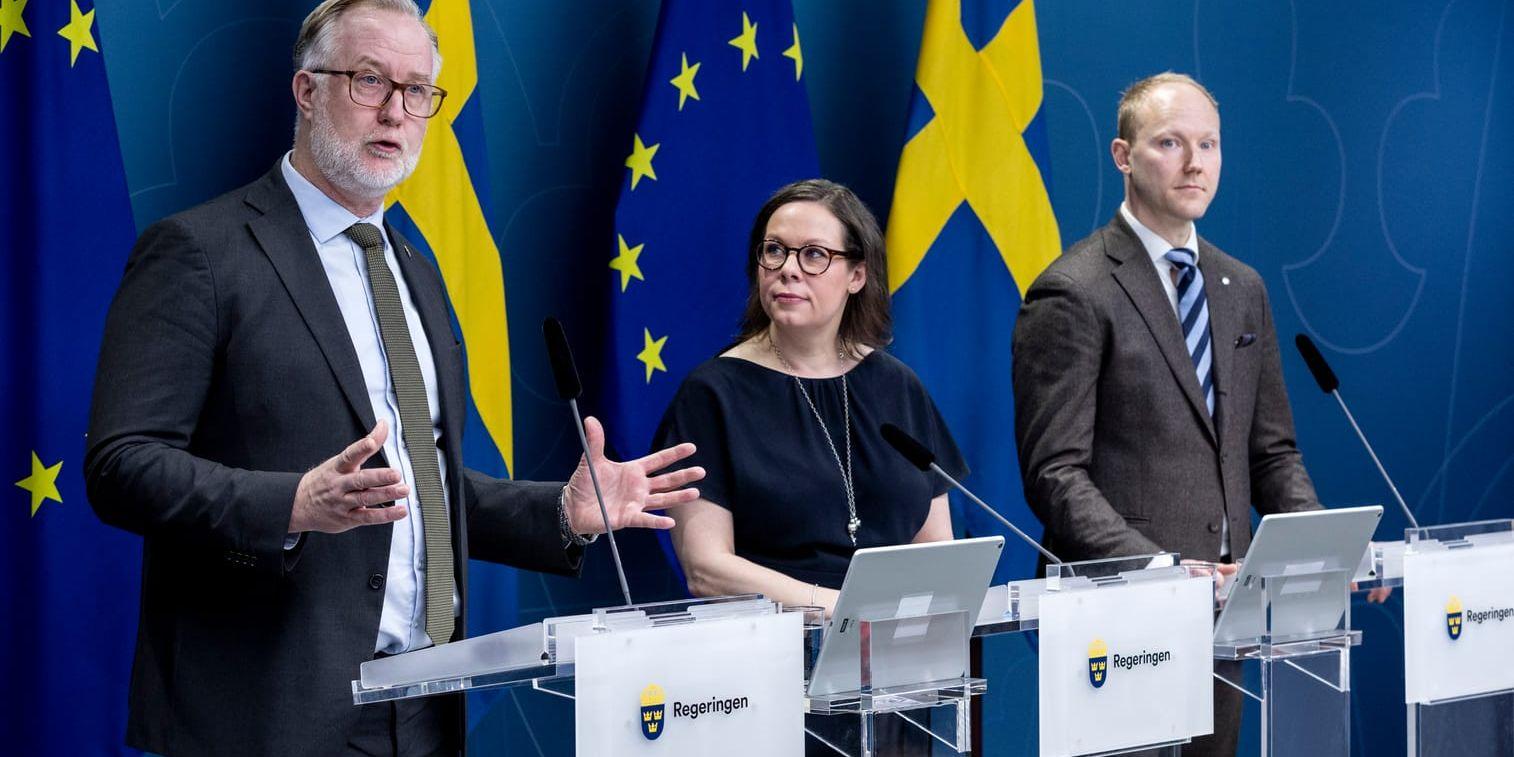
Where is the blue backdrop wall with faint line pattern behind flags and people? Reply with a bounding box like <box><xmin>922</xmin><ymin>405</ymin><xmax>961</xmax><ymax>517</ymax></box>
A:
<box><xmin>0</xmin><ymin>0</ymin><xmax>1514</xmax><ymax>754</ymax></box>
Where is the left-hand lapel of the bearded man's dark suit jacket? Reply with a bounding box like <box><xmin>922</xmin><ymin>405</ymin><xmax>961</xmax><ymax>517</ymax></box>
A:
<box><xmin>247</xmin><ymin>167</ymin><xmax>374</xmax><ymax>430</ymax></box>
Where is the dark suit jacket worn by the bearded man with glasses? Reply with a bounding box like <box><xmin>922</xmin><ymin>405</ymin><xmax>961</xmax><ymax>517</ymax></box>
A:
<box><xmin>85</xmin><ymin>167</ymin><xmax>580</xmax><ymax>755</ymax></box>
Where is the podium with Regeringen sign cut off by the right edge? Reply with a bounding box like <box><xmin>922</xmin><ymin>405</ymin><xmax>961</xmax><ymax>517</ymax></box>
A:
<box><xmin>1376</xmin><ymin>519</ymin><xmax>1514</xmax><ymax>757</ymax></box>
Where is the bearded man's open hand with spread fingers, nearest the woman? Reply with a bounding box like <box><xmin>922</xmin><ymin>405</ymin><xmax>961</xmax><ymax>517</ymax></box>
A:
<box><xmin>566</xmin><ymin>416</ymin><xmax>704</xmax><ymax>534</ymax></box>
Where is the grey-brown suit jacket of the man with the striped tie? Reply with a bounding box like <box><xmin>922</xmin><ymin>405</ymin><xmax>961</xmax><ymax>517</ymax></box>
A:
<box><xmin>1014</xmin><ymin>215</ymin><xmax>1319</xmax><ymax>560</ymax></box>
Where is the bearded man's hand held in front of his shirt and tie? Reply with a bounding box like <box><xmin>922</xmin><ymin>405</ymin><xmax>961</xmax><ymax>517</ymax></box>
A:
<box><xmin>289</xmin><ymin>421</ymin><xmax>410</xmax><ymax>533</ymax></box>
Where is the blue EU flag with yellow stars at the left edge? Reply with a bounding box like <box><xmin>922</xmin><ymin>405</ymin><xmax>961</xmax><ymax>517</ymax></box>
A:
<box><xmin>0</xmin><ymin>0</ymin><xmax>141</xmax><ymax>754</ymax></box>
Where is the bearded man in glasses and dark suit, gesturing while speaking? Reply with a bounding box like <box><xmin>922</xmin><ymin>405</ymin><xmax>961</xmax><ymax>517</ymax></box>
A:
<box><xmin>85</xmin><ymin>0</ymin><xmax>702</xmax><ymax>755</ymax></box>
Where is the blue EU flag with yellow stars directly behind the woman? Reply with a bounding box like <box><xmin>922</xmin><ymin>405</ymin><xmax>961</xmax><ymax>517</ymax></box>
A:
<box><xmin>604</xmin><ymin>0</ymin><xmax>819</xmax><ymax>457</ymax></box>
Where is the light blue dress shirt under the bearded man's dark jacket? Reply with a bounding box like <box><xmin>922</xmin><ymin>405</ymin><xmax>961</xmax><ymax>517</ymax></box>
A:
<box><xmin>282</xmin><ymin>154</ymin><xmax>460</xmax><ymax>654</ymax></box>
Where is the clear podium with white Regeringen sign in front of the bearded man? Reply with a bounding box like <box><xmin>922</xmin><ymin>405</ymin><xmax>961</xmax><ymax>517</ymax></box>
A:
<box><xmin>351</xmin><ymin>595</ymin><xmax>804</xmax><ymax>757</ymax></box>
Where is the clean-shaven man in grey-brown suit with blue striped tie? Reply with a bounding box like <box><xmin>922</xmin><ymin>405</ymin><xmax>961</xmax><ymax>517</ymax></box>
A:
<box><xmin>1014</xmin><ymin>73</ymin><xmax>1319</xmax><ymax>754</ymax></box>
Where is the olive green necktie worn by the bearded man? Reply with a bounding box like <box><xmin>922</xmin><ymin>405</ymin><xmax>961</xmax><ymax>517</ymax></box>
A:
<box><xmin>345</xmin><ymin>224</ymin><xmax>453</xmax><ymax>643</ymax></box>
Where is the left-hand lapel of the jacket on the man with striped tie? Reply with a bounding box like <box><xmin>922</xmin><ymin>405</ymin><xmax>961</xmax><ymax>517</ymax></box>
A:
<box><xmin>1104</xmin><ymin>215</ymin><xmax>1217</xmax><ymax>442</ymax></box>
